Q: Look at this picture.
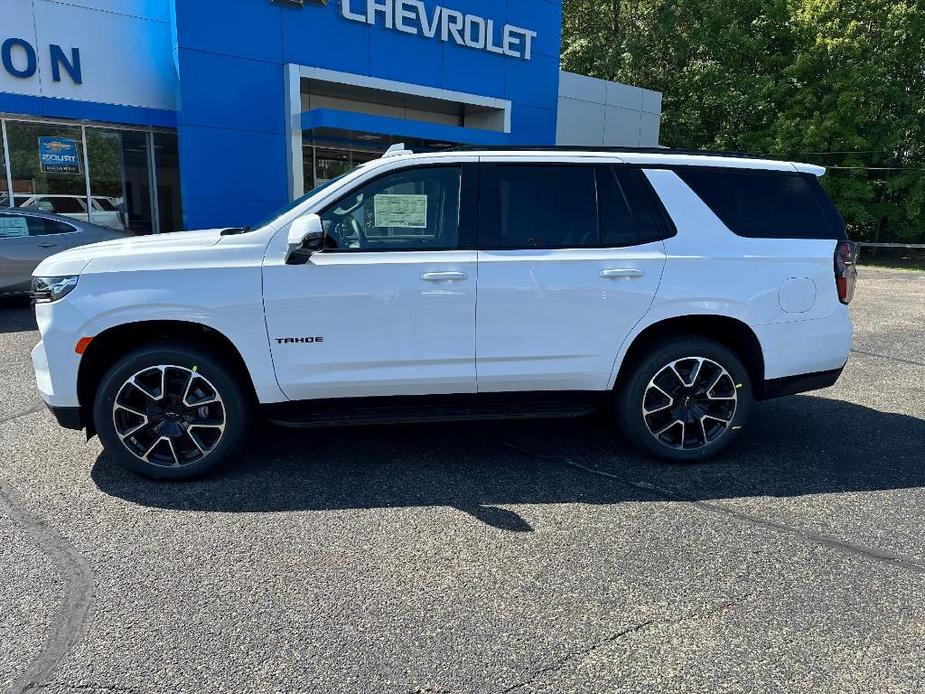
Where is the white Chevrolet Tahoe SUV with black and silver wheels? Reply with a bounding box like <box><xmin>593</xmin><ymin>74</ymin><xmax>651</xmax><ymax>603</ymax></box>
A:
<box><xmin>33</xmin><ymin>147</ymin><xmax>855</xmax><ymax>478</ymax></box>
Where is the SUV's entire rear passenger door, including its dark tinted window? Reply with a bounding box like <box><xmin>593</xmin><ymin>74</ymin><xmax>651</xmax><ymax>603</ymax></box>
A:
<box><xmin>476</xmin><ymin>160</ymin><xmax>665</xmax><ymax>392</ymax></box>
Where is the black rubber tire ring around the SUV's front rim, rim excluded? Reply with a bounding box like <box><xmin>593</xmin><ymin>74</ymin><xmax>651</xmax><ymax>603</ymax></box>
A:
<box><xmin>93</xmin><ymin>344</ymin><xmax>251</xmax><ymax>480</ymax></box>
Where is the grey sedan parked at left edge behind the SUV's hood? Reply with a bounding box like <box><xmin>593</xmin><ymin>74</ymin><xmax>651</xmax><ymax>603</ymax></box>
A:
<box><xmin>0</xmin><ymin>207</ymin><xmax>132</xmax><ymax>296</ymax></box>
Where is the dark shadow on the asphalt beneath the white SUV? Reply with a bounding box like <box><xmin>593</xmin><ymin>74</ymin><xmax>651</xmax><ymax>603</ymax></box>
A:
<box><xmin>91</xmin><ymin>396</ymin><xmax>925</xmax><ymax>532</ymax></box>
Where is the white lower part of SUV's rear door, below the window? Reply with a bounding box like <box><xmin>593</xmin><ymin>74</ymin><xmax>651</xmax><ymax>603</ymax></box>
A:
<box><xmin>476</xmin><ymin>249</ymin><xmax>665</xmax><ymax>392</ymax></box>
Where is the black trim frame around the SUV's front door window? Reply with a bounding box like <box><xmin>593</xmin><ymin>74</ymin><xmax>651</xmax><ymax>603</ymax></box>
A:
<box><xmin>315</xmin><ymin>161</ymin><xmax>481</xmax><ymax>254</ymax></box>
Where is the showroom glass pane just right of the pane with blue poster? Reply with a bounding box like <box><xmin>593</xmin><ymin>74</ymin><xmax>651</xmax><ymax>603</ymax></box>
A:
<box><xmin>87</xmin><ymin>128</ymin><xmax>154</xmax><ymax>234</ymax></box>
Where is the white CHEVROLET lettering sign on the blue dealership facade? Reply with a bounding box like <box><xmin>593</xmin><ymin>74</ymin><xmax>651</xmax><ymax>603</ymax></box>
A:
<box><xmin>341</xmin><ymin>0</ymin><xmax>537</xmax><ymax>60</ymax></box>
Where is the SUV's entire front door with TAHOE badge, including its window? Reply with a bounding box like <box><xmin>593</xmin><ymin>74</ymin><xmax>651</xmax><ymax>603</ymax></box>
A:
<box><xmin>264</xmin><ymin>163</ymin><xmax>478</xmax><ymax>400</ymax></box>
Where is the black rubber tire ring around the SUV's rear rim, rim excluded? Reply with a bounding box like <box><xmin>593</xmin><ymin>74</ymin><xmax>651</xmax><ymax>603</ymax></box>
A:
<box><xmin>617</xmin><ymin>337</ymin><xmax>753</xmax><ymax>462</ymax></box>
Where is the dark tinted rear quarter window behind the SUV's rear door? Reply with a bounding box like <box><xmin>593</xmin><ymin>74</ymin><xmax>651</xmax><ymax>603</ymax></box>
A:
<box><xmin>675</xmin><ymin>168</ymin><xmax>847</xmax><ymax>240</ymax></box>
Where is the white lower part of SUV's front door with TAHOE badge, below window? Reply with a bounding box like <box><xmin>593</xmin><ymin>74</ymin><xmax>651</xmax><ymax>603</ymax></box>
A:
<box><xmin>264</xmin><ymin>251</ymin><xmax>478</xmax><ymax>400</ymax></box>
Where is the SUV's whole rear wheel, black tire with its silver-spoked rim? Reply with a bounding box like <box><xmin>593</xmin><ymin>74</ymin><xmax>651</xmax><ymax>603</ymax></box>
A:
<box><xmin>616</xmin><ymin>335</ymin><xmax>753</xmax><ymax>462</ymax></box>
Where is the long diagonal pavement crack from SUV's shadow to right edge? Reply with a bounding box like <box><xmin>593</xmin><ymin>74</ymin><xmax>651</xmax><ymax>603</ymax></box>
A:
<box><xmin>500</xmin><ymin>441</ymin><xmax>925</xmax><ymax>574</ymax></box>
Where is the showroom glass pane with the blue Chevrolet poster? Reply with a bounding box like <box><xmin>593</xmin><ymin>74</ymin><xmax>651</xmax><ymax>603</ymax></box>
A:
<box><xmin>6</xmin><ymin>121</ymin><xmax>88</xmax><ymax>221</ymax></box>
